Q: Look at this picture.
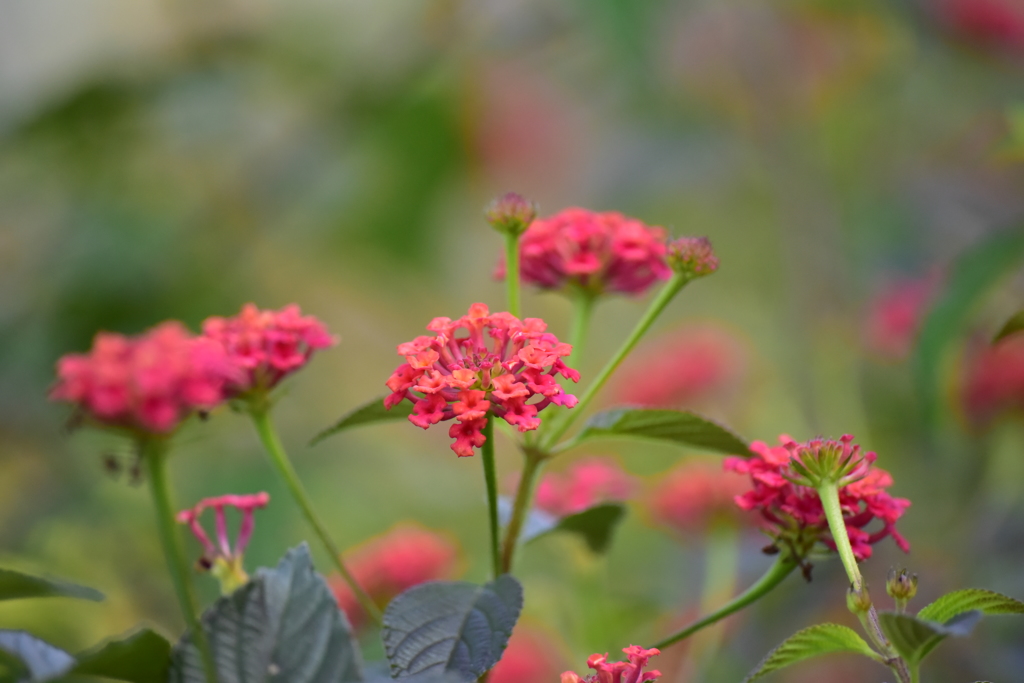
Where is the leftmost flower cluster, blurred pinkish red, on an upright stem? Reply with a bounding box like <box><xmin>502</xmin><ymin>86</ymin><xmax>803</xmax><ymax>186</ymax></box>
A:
<box><xmin>50</xmin><ymin>321</ymin><xmax>238</xmax><ymax>434</ymax></box>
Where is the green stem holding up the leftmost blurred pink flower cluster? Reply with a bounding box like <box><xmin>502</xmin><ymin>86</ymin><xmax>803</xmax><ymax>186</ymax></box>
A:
<box><xmin>139</xmin><ymin>438</ymin><xmax>217</xmax><ymax>683</ymax></box>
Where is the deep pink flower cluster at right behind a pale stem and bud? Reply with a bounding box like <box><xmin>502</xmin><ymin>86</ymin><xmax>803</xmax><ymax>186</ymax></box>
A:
<box><xmin>725</xmin><ymin>434</ymin><xmax>910</xmax><ymax>560</ymax></box>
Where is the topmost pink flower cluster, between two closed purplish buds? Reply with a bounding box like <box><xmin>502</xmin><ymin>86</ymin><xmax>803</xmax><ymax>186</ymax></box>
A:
<box><xmin>498</xmin><ymin>208</ymin><xmax>672</xmax><ymax>294</ymax></box>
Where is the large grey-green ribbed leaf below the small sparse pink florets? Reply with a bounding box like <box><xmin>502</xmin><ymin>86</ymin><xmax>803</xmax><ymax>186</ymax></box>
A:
<box><xmin>169</xmin><ymin>544</ymin><xmax>362</xmax><ymax>683</ymax></box>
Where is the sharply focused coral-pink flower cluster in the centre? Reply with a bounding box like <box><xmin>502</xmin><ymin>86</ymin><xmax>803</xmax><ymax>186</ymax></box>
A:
<box><xmin>384</xmin><ymin>303</ymin><xmax>580</xmax><ymax>457</ymax></box>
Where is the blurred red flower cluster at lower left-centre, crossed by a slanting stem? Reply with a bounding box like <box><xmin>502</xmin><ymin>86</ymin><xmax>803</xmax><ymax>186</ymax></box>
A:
<box><xmin>330</xmin><ymin>525</ymin><xmax>459</xmax><ymax>626</ymax></box>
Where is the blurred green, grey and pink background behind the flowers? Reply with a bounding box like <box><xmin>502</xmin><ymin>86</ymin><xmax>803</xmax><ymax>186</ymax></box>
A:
<box><xmin>0</xmin><ymin>0</ymin><xmax>1024</xmax><ymax>683</ymax></box>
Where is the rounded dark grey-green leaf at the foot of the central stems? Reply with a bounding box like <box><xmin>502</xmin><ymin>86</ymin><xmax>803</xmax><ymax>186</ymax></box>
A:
<box><xmin>381</xmin><ymin>574</ymin><xmax>522</xmax><ymax>680</ymax></box>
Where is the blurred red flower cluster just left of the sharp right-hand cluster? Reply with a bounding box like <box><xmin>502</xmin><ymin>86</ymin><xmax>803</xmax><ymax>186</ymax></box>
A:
<box><xmin>647</xmin><ymin>460</ymin><xmax>749</xmax><ymax>533</ymax></box>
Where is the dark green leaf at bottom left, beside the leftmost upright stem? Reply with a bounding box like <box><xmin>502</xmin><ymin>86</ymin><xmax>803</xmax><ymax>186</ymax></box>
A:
<box><xmin>72</xmin><ymin>629</ymin><xmax>171</xmax><ymax>683</ymax></box>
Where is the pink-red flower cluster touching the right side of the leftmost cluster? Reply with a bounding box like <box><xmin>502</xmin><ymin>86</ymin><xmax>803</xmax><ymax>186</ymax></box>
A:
<box><xmin>203</xmin><ymin>303</ymin><xmax>338</xmax><ymax>395</ymax></box>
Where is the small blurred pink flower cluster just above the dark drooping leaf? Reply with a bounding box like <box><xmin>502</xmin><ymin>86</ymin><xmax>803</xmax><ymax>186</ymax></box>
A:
<box><xmin>535</xmin><ymin>458</ymin><xmax>635</xmax><ymax>517</ymax></box>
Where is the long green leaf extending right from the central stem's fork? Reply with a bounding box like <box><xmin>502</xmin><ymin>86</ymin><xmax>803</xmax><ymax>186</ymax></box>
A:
<box><xmin>577</xmin><ymin>408</ymin><xmax>750</xmax><ymax>456</ymax></box>
